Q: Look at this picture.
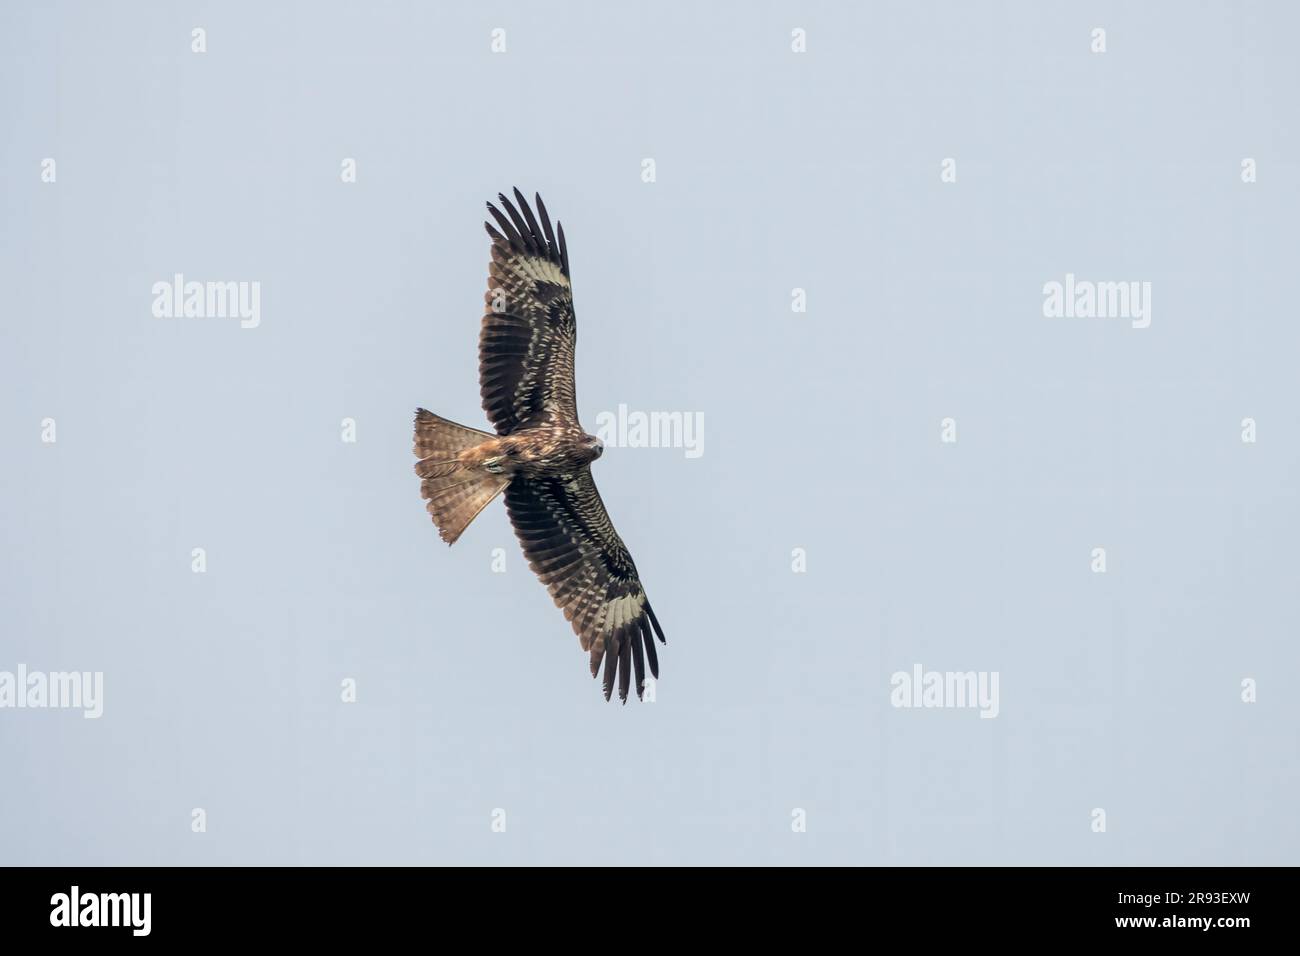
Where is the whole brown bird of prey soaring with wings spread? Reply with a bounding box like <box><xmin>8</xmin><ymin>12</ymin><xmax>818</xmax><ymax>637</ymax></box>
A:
<box><xmin>415</xmin><ymin>189</ymin><xmax>664</xmax><ymax>704</ymax></box>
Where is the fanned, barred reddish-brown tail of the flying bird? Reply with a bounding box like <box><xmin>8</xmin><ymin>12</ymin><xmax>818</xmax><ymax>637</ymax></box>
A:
<box><xmin>415</xmin><ymin>408</ymin><xmax>510</xmax><ymax>545</ymax></box>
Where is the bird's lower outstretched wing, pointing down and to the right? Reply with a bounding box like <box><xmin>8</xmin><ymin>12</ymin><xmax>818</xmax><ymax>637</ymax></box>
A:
<box><xmin>506</xmin><ymin>467</ymin><xmax>664</xmax><ymax>702</ymax></box>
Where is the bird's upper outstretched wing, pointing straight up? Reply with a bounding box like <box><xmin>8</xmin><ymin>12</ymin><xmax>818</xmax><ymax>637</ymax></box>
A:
<box><xmin>478</xmin><ymin>189</ymin><xmax>577</xmax><ymax>434</ymax></box>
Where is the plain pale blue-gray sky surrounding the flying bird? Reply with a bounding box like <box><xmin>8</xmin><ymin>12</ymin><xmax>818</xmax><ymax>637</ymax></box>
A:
<box><xmin>0</xmin><ymin>1</ymin><xmax>1300</xmax><ymax>864</ymax></box>
